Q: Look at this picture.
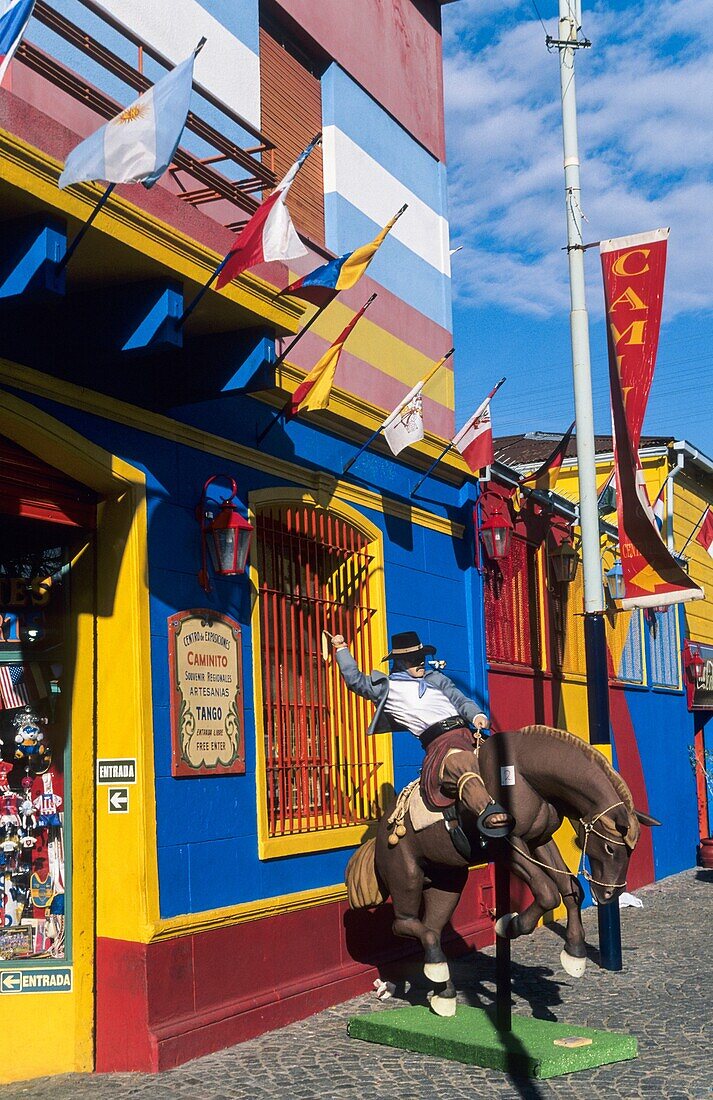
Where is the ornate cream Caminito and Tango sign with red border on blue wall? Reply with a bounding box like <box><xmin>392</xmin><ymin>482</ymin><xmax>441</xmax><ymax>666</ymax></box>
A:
<box><xmin>168</xmin><ymin>609</ymin><xmax>245</xmax><ymax>776</ymax></box>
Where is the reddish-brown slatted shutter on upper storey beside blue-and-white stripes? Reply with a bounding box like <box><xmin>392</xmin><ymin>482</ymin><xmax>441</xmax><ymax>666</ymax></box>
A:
<box><xmin>260</xmin><ymin>28</ymin><xmax>325</xmax><ymax>245</ymax></box>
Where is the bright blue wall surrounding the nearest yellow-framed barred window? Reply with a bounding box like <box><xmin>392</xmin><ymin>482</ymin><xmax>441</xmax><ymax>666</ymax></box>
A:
<box><xmin>16</xmin><ymin>395</ymin><xmax>484</xmax><ymax>917</ymax></box>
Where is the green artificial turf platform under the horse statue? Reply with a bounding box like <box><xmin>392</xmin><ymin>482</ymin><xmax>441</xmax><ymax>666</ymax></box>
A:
<box><xmin>348</xmin><ymin>1004</ymin><xmax>637</xmax><ymax>1078</ymax></box>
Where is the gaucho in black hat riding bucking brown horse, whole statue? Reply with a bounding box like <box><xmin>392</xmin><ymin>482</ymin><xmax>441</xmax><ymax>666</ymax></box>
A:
<box><xmin>331</xmin><ymin>631</ymin><xmax>660</xmax><ymax>1015</ymax></box>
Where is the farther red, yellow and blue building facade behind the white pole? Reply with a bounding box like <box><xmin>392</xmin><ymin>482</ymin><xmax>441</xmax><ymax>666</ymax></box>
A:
<box><xmin>481</xmin><ymin>432</ymin><xmax>713</xmax><ymax>889</ymax></box>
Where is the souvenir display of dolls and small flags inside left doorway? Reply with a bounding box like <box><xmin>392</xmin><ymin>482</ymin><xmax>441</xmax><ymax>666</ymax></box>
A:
<box><xmin>0</xmin><ymin>530</ymin><xmax>69</xmax><ymax>966</ymax></box>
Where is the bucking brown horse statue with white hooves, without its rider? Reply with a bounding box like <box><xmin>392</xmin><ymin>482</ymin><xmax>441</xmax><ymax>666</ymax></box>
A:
<box><xmin>345</xmin><ymin>725</ymin><xmax>660</xmax><ymax>1015</ymax></box>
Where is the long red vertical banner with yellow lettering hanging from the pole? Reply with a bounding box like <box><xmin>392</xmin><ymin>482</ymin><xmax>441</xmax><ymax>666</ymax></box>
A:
<box><xmin>600</xmin><ymin>229</ymin><xmax>703</xmax><ymax>609</ymax></box>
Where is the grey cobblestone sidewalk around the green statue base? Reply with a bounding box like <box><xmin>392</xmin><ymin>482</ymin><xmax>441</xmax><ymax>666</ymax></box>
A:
<box><xmin>6</xmin><ymin>869</ymin><xmax>713</xmax><ymax>1100</ymax></box>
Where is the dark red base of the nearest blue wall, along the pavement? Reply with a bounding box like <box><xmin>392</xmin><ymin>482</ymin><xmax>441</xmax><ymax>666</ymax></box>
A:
<box><xmin>97</xmin><ymin>867</ymin><xmax>495</xmax><ymax>1073</ymax></box>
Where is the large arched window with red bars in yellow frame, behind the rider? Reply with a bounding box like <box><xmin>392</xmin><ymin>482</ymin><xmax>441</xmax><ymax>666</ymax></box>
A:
<box><xmin>255</xmin><ymin>504</ymin><xmax>384</xmax><ymax>837</ymax></box>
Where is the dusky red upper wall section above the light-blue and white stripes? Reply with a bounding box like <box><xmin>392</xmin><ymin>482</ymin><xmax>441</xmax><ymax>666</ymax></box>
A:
<box><xmin>274</xmin><ymin>0</ymin><xmax>446</xmax><ymax>161</ymax></box>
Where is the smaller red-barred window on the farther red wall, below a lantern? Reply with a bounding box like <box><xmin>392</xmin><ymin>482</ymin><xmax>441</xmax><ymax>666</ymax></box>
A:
<box><xmin>485</xmin><ymin>536</ymin><xmax>540</xmax><ymax>668</ymax></box>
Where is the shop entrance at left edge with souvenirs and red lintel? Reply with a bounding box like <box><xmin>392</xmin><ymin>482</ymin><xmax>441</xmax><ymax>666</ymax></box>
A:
<box><xmin>0</xmin><ymin>438</ymin><xmax>97</xmax><ymax>1073</ymax></box>
